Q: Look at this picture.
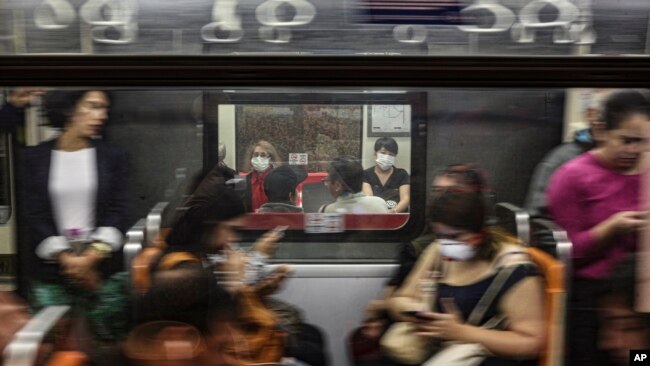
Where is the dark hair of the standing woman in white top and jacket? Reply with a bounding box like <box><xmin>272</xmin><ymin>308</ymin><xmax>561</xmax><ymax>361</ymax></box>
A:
<box><xmin>44</xmin><ymin>89</ymin><xmax>110</xmax><ymax>128</ymax></box>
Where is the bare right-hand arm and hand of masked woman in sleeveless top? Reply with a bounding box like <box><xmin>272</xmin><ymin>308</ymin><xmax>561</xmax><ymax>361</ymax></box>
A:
<box><xmin>417</xmin><ymin>277</ymin><xmax>545</xmax><ymax>358</ymax></box>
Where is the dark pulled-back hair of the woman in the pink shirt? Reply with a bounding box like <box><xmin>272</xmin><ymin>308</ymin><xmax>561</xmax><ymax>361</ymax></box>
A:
<box><xmin>603</xmin><ymin>89</ymin><xmax>650</xmax><ymax>130</ymax></box>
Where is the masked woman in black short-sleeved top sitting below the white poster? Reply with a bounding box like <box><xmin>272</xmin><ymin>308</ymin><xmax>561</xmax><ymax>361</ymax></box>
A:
<box><xmin>363</xmin><ymin>137</ymin><xmax>411</xmax><ymax>213</ymax></box>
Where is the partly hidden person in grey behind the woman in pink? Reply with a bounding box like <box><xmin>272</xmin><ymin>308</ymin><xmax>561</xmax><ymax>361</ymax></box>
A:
<box><xmin>524</xmin><ymin>89</ymin><xmax>612</xmax><ymax>217</ymax></box>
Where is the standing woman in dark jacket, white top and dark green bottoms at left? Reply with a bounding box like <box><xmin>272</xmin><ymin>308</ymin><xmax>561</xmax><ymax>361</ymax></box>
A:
<box><xmin>20</xmin><ymin>90</ymin><xmax>128</xmax><ymax>341</ymax></box>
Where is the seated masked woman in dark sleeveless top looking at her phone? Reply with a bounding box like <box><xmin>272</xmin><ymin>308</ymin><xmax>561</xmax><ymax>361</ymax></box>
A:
<box><xmin>389</xmin><ymin>189</ymin><xmax>544</xmax><ymax>365</ymax></box>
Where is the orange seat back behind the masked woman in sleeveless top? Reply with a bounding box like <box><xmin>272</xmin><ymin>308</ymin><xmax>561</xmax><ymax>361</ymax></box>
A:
<box><xmin>526</xmin><ymin>247</ymin><xmax>567</xmax><ymax>366</ymax></box>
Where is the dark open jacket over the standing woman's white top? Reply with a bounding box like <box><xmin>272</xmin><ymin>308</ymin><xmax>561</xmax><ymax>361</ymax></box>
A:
<box><xmin>19</xmin><ymin>140</ymin><xmax>128</xmax><ymax>280</ymax></box>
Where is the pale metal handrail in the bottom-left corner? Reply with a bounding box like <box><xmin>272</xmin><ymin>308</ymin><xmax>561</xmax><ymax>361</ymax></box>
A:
<box><xmin>4</xmin><ymin>305</ymin><xmax>70</xmax><ymax>366</ymax></box>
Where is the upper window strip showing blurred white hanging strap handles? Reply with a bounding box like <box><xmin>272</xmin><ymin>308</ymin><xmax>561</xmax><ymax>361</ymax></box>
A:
<box><xmin>0</xmin><ymin>0</ymin><xmax>650</xmax><ymax>56</ymax></box>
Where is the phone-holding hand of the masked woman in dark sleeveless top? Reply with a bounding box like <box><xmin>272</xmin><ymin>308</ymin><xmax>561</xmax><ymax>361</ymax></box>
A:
<box><xmin>415</xmin><ymin>299</ymin><xmax>471</xmax><ymax>341</ymax></box>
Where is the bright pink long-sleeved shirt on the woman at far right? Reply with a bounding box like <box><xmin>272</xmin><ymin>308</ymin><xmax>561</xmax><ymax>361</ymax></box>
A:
<box><xmin>546</xmin><ymin>152</ymin><xmax>641</xmax><ymax>279</ymax></box>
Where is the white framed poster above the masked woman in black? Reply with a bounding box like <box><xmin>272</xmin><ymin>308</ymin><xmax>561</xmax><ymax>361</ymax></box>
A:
<box><xmin>368</xmin><ymin>104</ymin><xmax>411</xmax><ymax>137</ymax></box>
